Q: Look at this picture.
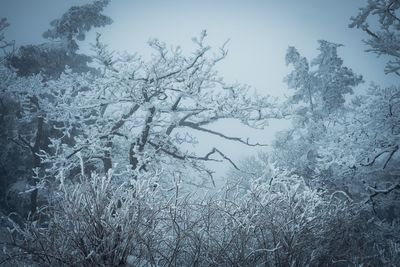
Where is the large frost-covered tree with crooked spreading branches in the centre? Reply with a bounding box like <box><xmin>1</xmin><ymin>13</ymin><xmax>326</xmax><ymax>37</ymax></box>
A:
<box><xmin>41</xmin><ymin>32</ymin><xmax>280</xmax><ymax>188</ymax></box>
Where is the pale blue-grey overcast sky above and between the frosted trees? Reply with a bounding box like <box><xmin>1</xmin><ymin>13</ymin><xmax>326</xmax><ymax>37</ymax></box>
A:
<box><xmin>0</xmin><ymin>0</ymin><xmax>395</xmax><ymax>182</ymax></box>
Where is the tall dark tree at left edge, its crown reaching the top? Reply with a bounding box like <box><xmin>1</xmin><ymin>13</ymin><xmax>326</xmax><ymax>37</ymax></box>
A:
<box><xmin>0</xmin><ymin>1</ymin><xmax>112</xmax><ymax>213</ymax></box>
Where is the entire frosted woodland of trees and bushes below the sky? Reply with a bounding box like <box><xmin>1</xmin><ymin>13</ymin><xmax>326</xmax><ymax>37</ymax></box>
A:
<box><xmin>0</xmin><ymin>0</ymin><xmax>400</xmax><ymax>266</ymax></box>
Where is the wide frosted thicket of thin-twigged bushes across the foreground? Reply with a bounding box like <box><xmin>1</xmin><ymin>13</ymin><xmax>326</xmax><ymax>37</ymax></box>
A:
<box><xmin>5</xmin><ymin>175</ymin><xmax>400</xmax><ymax>266</ymax></box>
